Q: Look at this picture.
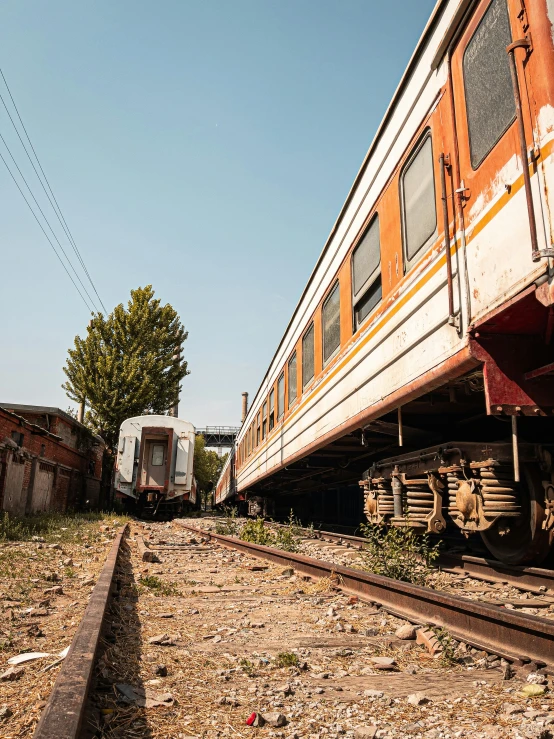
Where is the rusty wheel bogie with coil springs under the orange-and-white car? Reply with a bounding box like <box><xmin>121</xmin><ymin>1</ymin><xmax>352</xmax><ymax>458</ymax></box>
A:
<box><xmin>360</xmin><ymin>441</ymin><xmax>554</xmax><ymax>564</ymax></box>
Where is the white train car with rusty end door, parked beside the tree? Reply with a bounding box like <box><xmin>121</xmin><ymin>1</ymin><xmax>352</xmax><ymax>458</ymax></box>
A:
<box><xmin>114</xmin><ymin>415</ymin><xmax>196</xmax><ymax>514</ymax></box>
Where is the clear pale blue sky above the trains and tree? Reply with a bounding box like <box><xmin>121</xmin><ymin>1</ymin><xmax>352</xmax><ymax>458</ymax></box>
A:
<box><xmin>0</xmin><ymin>0</ymin><xmax>434</xmax><ymax>426</ymax></box>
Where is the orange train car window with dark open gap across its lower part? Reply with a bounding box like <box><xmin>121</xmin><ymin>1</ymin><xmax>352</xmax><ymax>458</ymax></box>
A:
<box><xmin>352</xmin><ymin>215</ymin><xmax>383</xmax><ymax>330</ymax></box>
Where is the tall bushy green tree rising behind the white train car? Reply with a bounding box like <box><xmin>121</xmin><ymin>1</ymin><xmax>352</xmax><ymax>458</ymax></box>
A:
<box><xmin>62</xmin><ymin>285</ymin><xmax>189</xmax><ymax>451</ymax></box>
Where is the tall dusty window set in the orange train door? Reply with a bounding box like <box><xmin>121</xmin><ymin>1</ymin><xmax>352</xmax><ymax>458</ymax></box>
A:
<box><xmin>463</xmin><ymin>0</ymin><xmax>516</xmax><ymax>169</ymax></box>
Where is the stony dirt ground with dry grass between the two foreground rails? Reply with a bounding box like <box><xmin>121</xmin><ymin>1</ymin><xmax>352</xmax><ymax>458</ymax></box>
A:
<box><xmin>83</xmin><ymin>522</ymin><xmax>554</xmax><ymax>739</ymax></box>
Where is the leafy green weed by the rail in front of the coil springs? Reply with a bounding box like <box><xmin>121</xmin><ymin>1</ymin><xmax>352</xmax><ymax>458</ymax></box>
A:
<box><xmin>360</xmin><ymin>524</ymin><xmax>439</xmax><ymax>585</ymax></box>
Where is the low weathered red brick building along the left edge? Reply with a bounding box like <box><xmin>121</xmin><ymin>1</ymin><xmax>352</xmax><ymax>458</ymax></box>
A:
<box><xmin>0</xmin><ymin>403</ymin><xmax>104</xmax><ymax>516</ymax></box>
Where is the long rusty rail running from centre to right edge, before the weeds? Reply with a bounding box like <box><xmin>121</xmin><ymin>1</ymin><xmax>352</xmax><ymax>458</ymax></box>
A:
<box><xmin>175</xmin><ymin>520</ymin><xmax>554</xmax><ymax>666</ymax></box>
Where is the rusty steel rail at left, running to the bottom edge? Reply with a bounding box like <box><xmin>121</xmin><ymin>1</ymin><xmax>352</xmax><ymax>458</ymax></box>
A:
<box><xmin>33</xmin><ymin>524</ymin><xmax>127</xmax><ymax>739</ymax></box>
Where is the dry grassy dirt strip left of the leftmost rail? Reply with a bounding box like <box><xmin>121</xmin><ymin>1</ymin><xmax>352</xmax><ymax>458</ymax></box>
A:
<box><xmin>0</xmin><ymin>515</ymin><xmax>123</xmax><ymax>739</ymax></box>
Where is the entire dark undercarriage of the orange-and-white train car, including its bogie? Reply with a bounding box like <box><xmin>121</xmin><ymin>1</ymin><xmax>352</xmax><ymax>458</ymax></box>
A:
<box><xmin>245</xmin><ymin>369</ymin><xmax>554</xmax><ymax>564</ymax></box>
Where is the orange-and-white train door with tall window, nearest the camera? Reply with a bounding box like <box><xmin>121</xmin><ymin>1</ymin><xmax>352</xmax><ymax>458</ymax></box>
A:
<box><xmin>451</xmin><ymin>0</ymin><xmax>544</xmax><ymax>318</ymax></box>
